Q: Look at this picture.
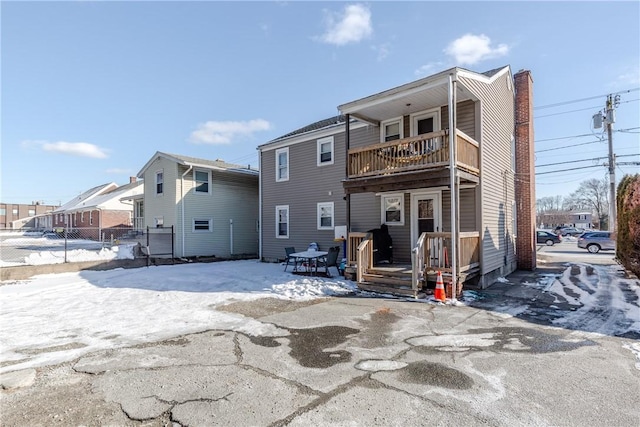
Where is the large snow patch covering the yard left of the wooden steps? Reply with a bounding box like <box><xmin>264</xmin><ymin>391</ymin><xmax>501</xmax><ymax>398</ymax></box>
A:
<box><xmin>0</xmin><ymin>260</ymin><xmax>355</xmax><ymax>372</ymax></box>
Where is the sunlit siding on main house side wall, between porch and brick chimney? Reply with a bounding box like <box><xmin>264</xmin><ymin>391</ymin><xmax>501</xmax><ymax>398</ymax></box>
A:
<box><xmin>459</xmin><ymin>73</ymin><xmax>515</xmax><ymax>274</ymax></box>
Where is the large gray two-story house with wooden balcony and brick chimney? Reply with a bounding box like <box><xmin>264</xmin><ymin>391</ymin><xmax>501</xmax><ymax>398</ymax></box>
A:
<box><xmin>259</xmin><ymin>66</ymin><xmax>535</xmax><ymax>295</ymax></box>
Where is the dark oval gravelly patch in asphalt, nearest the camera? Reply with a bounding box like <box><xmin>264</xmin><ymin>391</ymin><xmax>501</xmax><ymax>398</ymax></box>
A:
<box><xmin>398</xmin><ymin>361</ymin><xmax>473</xmax><ymax>390</ymax></box>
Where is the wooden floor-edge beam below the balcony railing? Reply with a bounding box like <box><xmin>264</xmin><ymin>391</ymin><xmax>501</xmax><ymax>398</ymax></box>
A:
<box><xmin>342</xmin><ymin>167</ymin><xmax>480</xmax><ymax>194</ymax></box>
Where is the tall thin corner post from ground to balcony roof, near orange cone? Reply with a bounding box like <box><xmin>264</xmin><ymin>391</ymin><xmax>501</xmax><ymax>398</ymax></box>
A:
<box><xmin>449</xmin><ymin>74</ymin><xmax>459</xmax><ymax>301</ymax></box>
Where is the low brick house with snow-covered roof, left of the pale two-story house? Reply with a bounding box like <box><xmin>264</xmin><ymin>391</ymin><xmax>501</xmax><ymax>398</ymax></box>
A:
<box><xmin>54</xmin><ymin>177</ymin><xmax>143</xmax><ymax>241</ymax></box>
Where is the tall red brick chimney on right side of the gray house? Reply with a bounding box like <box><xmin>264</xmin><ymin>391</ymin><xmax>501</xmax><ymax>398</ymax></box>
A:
<box><xmin>513</xmin><ymin>70</ymin><xmax>536</xmax><ymax>270</ymax></box>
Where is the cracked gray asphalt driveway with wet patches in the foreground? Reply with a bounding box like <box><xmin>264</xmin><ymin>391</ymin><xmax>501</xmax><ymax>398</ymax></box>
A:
<box><xmin>0</xmin><ymin>280</ymin><xmax>640</xmax><ymax>426</ymax></box>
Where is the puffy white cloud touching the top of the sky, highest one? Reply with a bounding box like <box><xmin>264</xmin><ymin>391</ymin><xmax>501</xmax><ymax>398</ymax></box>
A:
<box><xmin>318</xmin><ymin>4</ymin><xmax>373</xmax><ymax>46</ymax></box>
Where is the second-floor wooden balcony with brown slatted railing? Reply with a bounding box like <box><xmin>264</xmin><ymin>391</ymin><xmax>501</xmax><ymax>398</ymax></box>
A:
<box><xmin>344</xmin><ymin>129</ymin><xmax>480</xmax><ymax>193</ymax></box>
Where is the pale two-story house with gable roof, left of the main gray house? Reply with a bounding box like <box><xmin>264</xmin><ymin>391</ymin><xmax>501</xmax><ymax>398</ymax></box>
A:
<box><xmin>138</xmin><ymin>152</ymin><xmax>258</xmax><ymax>257</ymax></box>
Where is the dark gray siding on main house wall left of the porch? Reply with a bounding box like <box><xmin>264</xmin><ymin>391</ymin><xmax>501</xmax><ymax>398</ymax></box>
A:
<box><xmin>260</xmin><ymin>127</ymin><xmax>356</xmax><ymax>261</ymax></box>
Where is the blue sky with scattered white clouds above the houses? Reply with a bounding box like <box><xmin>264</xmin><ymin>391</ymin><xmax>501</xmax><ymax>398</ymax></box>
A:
<box><xmin>0</xmin><ymin>1</ymin><xmax>640</xmax><ymax>204</ymax></box>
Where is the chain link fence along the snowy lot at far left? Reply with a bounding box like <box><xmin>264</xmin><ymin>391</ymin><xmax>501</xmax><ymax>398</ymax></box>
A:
<box><xmin>0</xmin><ymin>227</ymin><xmax>174</xmax><ymax>267</ymax></box>
